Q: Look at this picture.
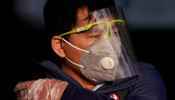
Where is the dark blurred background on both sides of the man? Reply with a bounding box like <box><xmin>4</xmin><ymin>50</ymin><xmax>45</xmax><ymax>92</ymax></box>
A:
<box><xmin>4</xmin><ymin>0</ymin><xmax>175</xmax><ymax>99</ymax></box>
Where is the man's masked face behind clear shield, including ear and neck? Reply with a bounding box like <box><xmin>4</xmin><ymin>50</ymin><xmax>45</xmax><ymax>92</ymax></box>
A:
<box><xmin>52</xmin><ymin>7</ymin><xmax>140</xmax><ymax>86</ymax></box>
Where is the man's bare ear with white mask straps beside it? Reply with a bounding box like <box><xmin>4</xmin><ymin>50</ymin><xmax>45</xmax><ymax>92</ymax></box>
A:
<box><xmin>51</xmin><ymin>36</ymin><xmax>65</xmax><ymax>58</ymax></box>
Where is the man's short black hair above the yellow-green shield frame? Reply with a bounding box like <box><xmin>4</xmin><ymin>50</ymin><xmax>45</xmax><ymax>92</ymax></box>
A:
<box><xmin>44</xmin><ymin>0</ymin><xmax>115</xmax><ymax>65</ymax></box>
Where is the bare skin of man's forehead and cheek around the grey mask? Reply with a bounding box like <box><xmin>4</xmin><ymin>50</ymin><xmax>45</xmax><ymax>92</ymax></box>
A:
<box><xmin>63</xmin><ymin>8</ymin><xmax>118</xmax><ymax>69</ymax></box>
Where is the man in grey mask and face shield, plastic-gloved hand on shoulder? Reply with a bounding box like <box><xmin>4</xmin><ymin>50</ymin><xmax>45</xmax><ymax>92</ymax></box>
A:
<box><xmin>14</xmin><ymin>0</ymin><xmax>166</xmax><ymax>100</ymax></box>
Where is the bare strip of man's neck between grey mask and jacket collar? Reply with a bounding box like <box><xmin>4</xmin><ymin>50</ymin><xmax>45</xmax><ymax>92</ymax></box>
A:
<box><xmin>61</xmin><ymin>63</ymin><xmax>97</xmax><ymax>90</ymax></box>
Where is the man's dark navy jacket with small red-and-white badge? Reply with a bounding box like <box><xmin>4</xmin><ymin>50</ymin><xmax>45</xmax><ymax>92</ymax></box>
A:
<box><xmin>17</xmin><ymin>60</ymin><xmax>167</xmax><ymax>100</ymax></box>
